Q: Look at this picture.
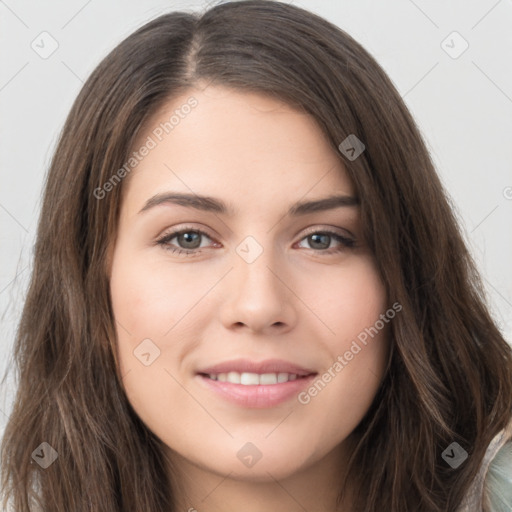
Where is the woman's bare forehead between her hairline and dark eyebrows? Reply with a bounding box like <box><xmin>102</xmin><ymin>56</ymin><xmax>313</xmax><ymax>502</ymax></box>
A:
<box><xmin>121</xmin><ymin>87</ymin><xmax>354</xmax><ymax>210</ymax></box>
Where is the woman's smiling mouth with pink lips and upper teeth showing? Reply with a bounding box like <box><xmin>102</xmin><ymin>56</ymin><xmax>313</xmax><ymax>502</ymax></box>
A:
<box><xmin>196</xmin><ymin>360</ymin><xmax>318</xmax><ymax>409</ymax></box>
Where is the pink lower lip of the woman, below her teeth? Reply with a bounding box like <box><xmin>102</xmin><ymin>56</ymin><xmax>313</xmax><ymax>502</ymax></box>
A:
<box><xmin>197</xmin><ymin>374</ymin><xmax>316</xmax><ymax>409</ymax></box>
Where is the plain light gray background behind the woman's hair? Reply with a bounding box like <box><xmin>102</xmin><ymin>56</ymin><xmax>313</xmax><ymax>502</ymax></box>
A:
<box><xmin>0</xmin><ymin>0</ymin><xmax>512</xmax><ymax>440</ymax></box>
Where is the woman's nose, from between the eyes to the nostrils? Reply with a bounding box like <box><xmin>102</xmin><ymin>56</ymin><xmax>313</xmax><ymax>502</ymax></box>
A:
<box><xmin>221</xmin><ymin>242</ymin><xmax>297</xmax><ymax>335</ymax></box>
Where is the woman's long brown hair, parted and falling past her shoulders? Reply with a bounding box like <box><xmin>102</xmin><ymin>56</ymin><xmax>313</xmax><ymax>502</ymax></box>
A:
<box><xmin>2</xmin><ymin>0</ymin><xmax>512</xmax><ymax>512</ymax></box>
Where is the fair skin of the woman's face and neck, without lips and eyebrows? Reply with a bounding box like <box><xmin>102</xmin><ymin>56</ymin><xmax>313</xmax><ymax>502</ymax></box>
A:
<box><xmin>109</xmin><ymin>86</ymin><xmax>389</xmax><ymax>512</ymax></box>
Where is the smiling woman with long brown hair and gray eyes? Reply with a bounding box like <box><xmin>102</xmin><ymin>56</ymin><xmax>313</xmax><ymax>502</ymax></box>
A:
<box><xmin>2</xmin><ymin>0</ymin><xmax>512</xmax><ymax>512</ymax></box>
